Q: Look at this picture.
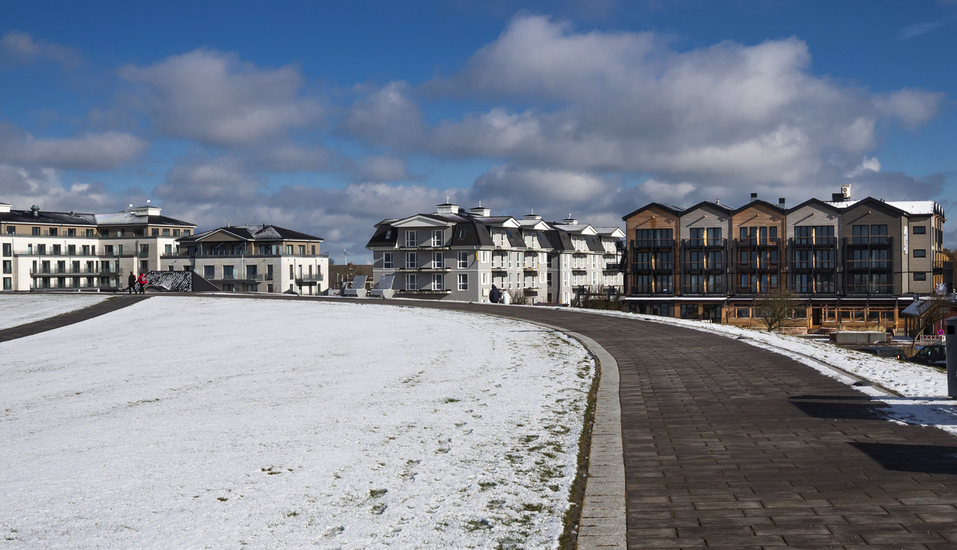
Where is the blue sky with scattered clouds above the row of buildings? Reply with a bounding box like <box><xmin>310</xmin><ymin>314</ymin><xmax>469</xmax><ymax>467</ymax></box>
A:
<box><xmin>0</xmin><ymin>0</ymin><xmax>957</xmax><ymax>262</ymax></box>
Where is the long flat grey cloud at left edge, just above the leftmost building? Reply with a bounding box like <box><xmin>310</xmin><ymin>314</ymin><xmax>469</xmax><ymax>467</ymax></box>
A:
<box><xmin>0</xmin><ymin>124</ymin><xmax>149</xmax><ymax>170</ymax></box>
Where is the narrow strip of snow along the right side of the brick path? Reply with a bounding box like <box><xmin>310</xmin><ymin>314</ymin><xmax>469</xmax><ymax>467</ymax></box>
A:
<box><xmin>568</xmin><ymin>310</ymin><xmax>957</xmax><ymax>435</ymax></box>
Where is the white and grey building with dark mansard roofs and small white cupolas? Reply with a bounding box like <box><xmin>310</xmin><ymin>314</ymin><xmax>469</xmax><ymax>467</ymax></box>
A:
<box><xmin>366</xmin><ymin>203</ymin><xmax>624</xmax><ymax>304</ymax></box>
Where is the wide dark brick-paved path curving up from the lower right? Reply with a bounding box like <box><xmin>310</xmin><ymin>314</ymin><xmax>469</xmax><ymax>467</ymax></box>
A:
<box><xmin>7</xmin><ymin>296</ymin><xmax>957</xmax><ymax>550</ymax></box>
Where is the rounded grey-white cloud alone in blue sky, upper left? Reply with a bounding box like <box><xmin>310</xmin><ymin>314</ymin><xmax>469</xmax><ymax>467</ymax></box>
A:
<box><xmin>119</xmin><ymin>49</ymin><xmax>323</xmax><ymax>147</ymax></box>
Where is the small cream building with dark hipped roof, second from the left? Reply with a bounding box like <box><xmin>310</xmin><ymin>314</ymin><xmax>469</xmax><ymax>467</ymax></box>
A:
<box><xmin>163</xmin><ymin>224</ymin><xmax>329</xmax><ymax>295</ymax></box>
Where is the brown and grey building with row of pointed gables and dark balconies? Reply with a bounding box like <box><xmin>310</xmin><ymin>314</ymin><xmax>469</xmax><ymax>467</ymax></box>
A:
<box><xmin>623</xmin><ymin>185</ymin><xmax>947</xmax><ymax>330</ymax></box>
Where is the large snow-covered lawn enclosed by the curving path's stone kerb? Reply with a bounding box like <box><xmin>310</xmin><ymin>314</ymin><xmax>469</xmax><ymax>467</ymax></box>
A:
<box><xmin>0</xmin><ymin>296</ymin><xmax>594</xmax><ymax>549</ymax></box>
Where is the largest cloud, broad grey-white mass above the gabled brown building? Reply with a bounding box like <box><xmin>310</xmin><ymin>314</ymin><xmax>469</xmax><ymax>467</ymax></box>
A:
<box><xmin>344</xmin><ymin>16</ymin><xmax>943</xmax><ymax>205</ymax></box>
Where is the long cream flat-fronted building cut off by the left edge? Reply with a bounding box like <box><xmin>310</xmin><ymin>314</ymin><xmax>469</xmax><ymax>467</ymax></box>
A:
<box><xmin>0</xmin><ymin>203</ymin><xmax>196</xmax><ymax>291</ymax></box>
